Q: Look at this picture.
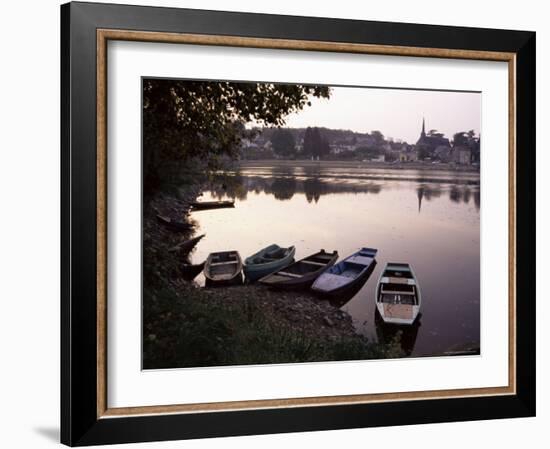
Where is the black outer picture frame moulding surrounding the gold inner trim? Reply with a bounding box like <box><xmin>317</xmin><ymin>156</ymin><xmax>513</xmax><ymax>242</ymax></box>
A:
<box><xmin>61</xmin><ymin>2</ymin><xmax>535</xmax><ymax>446</ymax></box>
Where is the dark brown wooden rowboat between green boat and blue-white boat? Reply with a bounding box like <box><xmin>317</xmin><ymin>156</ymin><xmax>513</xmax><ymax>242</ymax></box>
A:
<box><xmin>260</xmin><ymin>249</ymin><xmax>338</xmax><ymax>289</ymax></box>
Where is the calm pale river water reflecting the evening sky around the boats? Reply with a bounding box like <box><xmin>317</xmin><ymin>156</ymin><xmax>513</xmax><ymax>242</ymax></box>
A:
<box><xmin>184</xmin><ymin>165</ymin><xmax>480</xmax><ymax>356</ymax></box>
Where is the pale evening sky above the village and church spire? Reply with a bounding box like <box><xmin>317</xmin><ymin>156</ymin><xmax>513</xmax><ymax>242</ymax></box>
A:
<box><xmin>278</xmin><ymin>87</ymin><xmax>481</xmax><ymax>143</ymax></box>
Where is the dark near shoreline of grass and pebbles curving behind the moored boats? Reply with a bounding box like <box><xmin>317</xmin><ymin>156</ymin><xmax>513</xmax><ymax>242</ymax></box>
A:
<box><xmin>142</xmin><ymin>184</ymin><xmax>403</xmax><ymax>369</ymax></box>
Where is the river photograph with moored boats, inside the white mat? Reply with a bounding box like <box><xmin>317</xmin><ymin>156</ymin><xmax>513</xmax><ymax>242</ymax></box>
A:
<box><xmin>141</xmin><ymin>77</ymin><xmax>482</xmax><ymax>370</ymax></box>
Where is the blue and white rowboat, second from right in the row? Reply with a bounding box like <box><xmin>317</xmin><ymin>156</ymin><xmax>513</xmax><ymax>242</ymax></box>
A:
<box><xmin>311</xmin><ymin>248</ymin><xmax>378</xmax><ymax>296</ymax></box>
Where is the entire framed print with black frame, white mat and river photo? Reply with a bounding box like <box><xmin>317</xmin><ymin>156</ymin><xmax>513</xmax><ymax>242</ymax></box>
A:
<box><xmin>61</xmin><ymin>3</ymin><xmax>535</xmax><ymax>446</ymax></box>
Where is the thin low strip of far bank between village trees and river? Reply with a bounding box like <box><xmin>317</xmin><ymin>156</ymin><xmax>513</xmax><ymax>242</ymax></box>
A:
<box><xmin>237</xmin><ymin>159</ymin><xmax>479</xmax><ymax>173</ymax></box>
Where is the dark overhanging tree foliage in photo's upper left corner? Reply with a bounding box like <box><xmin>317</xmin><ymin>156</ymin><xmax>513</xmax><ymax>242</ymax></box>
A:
<box><xmin>143</xmin><ymin>79</ymin><xmax>330</xmax><ymax>189</ymax></box>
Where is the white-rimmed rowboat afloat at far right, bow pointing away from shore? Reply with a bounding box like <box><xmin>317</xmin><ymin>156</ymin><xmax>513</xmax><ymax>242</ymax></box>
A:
<box><xmin>376</xmin><ymin>262</ymin><xmax>422</xmax><ymax>324</ymax></box>
